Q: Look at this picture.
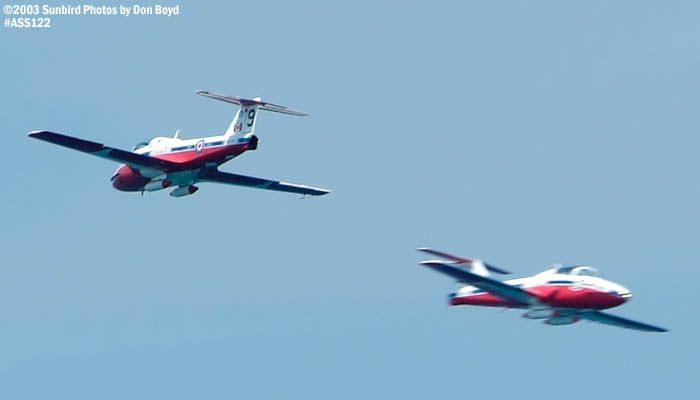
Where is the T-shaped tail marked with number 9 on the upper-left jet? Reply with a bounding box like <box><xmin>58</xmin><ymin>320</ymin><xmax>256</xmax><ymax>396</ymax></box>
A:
<box><xmin>196</xmin><ymin>90</ymin><xmax>309</xmax><ymax>138</ymax></box>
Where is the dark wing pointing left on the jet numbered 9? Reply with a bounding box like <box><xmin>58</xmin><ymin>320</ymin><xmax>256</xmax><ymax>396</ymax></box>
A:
<box><xmin>29</xmin><ymin>131</ymin><xmax>182</xmax><ymax>172</ymax></box>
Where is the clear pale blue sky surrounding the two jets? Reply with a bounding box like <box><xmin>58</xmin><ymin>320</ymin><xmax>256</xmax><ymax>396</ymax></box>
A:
<box><xmin>0</xmin><ymin>1</ymin><xmax>700</xmax><ymax>399</ymax></box>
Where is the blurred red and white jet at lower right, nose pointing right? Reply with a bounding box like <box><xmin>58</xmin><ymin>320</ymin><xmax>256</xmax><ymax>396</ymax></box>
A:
<box><xmin>418</xmin><ymin>247</ymin><xmax>667</xmax><ymax>332</ymax></box>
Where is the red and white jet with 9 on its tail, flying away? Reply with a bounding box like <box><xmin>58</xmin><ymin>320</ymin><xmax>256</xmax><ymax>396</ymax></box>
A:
<box><xmin>29</xmin><ymin>90</ymin><xmax>329</xmax><ymax>197</ymax></box>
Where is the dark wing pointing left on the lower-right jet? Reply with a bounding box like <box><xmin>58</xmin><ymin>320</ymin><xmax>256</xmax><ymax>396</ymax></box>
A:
<box><xmin>421</xmin><ymin>260</ymin><xmax>540</xmax><ymax>305</ymax></box>
